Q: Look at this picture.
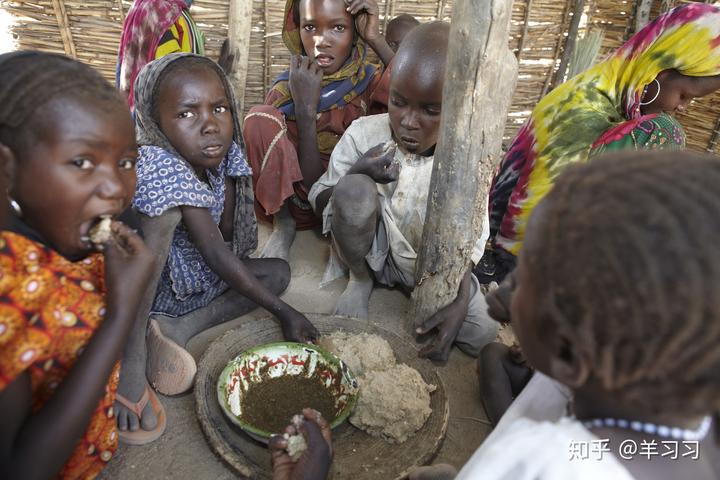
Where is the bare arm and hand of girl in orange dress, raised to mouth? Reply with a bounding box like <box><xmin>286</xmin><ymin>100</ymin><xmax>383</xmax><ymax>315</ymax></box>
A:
<box><xmin>0</xmin><ymin>222</ymin><xmax>154</xmax><ymax>480</ymax></box>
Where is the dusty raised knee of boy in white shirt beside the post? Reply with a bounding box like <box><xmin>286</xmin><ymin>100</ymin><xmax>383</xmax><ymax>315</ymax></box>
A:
<box><xmin>332</xmin><ymin>175</ymin><xmax>378</xmax><ymax>223</ymax></box>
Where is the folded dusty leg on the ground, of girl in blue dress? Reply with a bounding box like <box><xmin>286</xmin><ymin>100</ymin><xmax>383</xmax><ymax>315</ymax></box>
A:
<box><xmin>157</xmin><ymin>258</ymin><xmax>290</xmax><ymax>347</ymax></box>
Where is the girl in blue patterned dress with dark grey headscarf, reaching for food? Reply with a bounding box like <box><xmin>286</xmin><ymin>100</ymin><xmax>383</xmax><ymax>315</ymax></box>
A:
<box><xmin>133</xmin><ymin>54</ymin><xmax>318</xmax><ymax>394</ymax></box>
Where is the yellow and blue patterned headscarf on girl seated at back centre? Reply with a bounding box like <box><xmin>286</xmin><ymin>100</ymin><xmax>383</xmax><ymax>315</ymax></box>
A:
<box><xmin>270</xmin><ymin>0</ymin><xmax>378</xmax><ymax>120</ymax></box>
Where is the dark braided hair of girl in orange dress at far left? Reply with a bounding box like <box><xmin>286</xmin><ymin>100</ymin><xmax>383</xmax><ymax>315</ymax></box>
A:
<box><xmin>0</xmin><ymin>51</ymin><xmax>122</xmax><ymax>151</ymax></box>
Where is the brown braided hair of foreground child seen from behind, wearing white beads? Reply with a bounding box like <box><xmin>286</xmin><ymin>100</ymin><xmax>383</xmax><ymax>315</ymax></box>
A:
<box><xmin>523</xmin><ymin>152</ymin><xmax>720</xmax><ymax>415</ymax></box>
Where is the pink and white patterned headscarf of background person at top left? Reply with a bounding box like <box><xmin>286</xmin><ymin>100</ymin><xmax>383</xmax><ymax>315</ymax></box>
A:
<box><xmin>115</xmin><ymin>0</ymin><xmax>203</xmax><ymax>109</ymax></box>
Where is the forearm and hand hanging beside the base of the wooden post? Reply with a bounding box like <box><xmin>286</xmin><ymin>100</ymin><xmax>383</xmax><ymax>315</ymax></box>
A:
<box><xmin>416</xmin><ymin>267</ymin><xmax>472</xmax><ymax>362</ymax></box>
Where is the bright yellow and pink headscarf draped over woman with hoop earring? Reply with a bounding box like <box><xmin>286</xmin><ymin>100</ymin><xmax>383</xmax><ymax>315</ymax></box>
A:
<box><xmin>490</xmin><ymin>3</ymin><xmax>720</xmax><ymax>255</ymax></box>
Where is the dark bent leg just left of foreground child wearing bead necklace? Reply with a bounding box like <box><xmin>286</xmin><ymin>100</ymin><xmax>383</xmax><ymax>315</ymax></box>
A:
<box><xmin>477</xmin><ymin>342</ymin><xmax>532</xmax><ymax>426</ymax></box>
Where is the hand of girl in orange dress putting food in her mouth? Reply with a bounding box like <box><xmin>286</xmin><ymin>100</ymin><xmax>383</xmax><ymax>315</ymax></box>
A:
<box><xmin>104</xmin><ymin>221</ymin><xmax>155</xmax><ymax>316</ymax></box>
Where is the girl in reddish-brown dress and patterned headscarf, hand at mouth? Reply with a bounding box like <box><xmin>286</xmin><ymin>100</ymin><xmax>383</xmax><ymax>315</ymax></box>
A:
<box><xmin>243</xmin><ymin>0</ymin><xmax>393</xmax><ymax>259</ymax></box>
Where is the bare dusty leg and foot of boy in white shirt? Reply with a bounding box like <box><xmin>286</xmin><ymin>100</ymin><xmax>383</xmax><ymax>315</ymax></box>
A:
<box><xmin>330</xmin><ymin>175</ymin><xmax>379</xmax><ymax>318</ymax></box>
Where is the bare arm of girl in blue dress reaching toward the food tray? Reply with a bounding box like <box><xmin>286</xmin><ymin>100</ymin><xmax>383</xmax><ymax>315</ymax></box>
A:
<box><xmin>180</xmin><ymin>206</ymin><xmax>318</xmax><ymax>342</ymax></box>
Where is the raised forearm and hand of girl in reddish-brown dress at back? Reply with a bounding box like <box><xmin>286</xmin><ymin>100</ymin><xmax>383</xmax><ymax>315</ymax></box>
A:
<box><xmin>288</xmin><ymin>55</ymin><xmax>325</xmax><ymax>190</ymax></box>
